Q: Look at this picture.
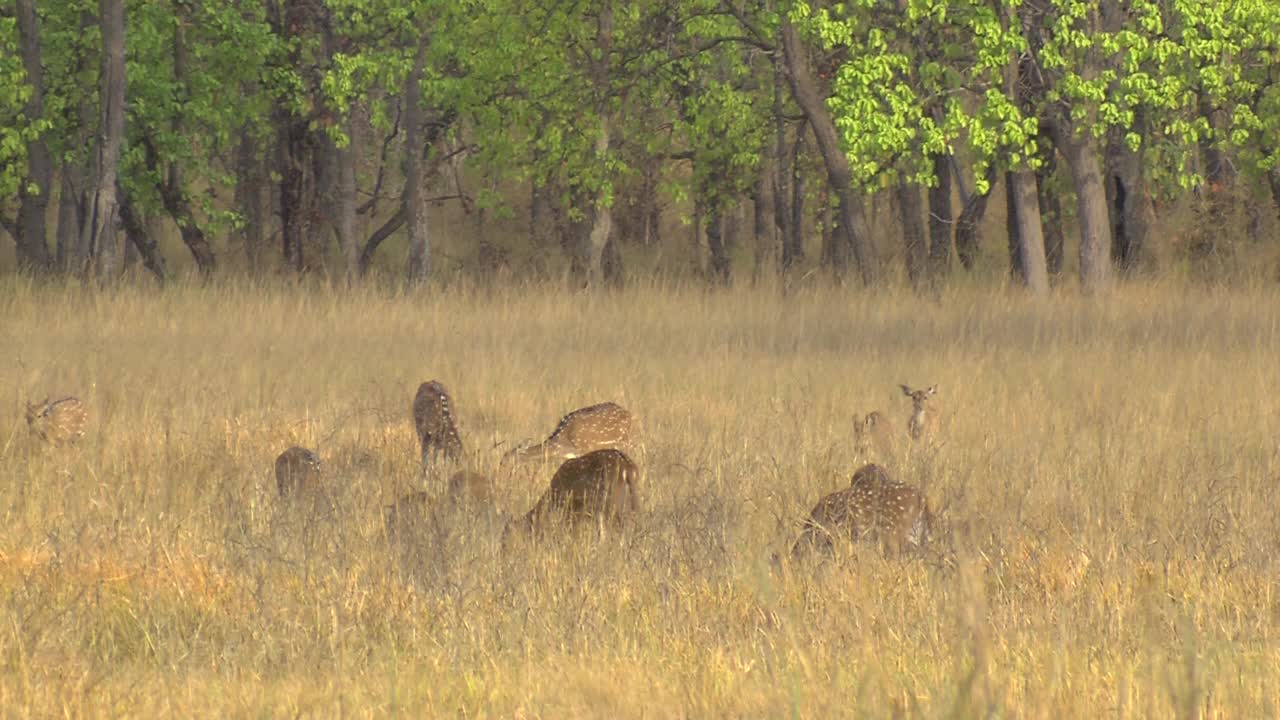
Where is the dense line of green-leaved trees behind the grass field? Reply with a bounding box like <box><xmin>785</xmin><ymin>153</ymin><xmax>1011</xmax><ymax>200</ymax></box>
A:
<box><xmin>0</xmin><ymin>0</ymin><xmax>1280</xmax><ymax>293</ymax></box>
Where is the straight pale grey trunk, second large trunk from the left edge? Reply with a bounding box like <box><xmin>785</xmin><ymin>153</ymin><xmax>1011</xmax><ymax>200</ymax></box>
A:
<box><xmin>82</xmin><ymin>0</ymin><xmax>125</xmax><ymax>283</ymax></box>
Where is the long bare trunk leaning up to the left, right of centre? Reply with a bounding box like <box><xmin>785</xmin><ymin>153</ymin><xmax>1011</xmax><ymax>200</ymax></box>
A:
<box><xmin>782</xmin><ymin>14</ymin><xmax>877</xmax><ymax>286</ymax></box>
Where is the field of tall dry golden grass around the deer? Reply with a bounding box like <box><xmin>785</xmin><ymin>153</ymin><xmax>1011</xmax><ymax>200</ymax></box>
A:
<box><xmin>0</xmin><ymin>281</ymin><xmax>1280</xmax><ymax>717</ymax></box>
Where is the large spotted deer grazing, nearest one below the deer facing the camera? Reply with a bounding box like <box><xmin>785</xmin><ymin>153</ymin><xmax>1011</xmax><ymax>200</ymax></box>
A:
<box><xmin>791</xmin><ymin>464</ymin><xmax>933</xmax><ymax>559</ymax></box>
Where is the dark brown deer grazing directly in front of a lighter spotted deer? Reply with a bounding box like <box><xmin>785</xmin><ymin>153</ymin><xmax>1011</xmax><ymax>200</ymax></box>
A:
<box><xmin>506</xmin><ymin>448</ymin><xmax>640</xmax><ymax>536</ymax></box>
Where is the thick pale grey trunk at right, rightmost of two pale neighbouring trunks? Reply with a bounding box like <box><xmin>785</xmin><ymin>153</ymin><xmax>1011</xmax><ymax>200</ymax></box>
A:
<box><xmin>1053</xmin><ymin>122</ymin><xmax>1111</xmax><ymax>295</ymax></box>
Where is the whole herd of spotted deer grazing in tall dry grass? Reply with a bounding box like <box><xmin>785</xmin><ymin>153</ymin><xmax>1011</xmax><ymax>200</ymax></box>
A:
<box><xmin>17</xmin><ymin>380</ymin><xmax>937</xmax><ymax>560</ymax></box>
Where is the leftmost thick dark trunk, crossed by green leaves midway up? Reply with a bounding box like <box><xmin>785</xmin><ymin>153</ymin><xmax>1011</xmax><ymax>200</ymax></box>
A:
<box><xmin>14</xmin><ymin>0</ymin><xmax>52</xmax><ymax>273</ymax></box>
